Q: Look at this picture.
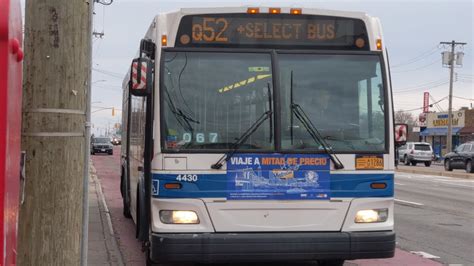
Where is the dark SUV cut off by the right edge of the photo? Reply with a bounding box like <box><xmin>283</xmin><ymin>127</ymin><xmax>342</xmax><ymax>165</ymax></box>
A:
<box><xmin>444</xmin><ymin>141</ymin><xmax>474</xmax><ymax>173</ymax></box>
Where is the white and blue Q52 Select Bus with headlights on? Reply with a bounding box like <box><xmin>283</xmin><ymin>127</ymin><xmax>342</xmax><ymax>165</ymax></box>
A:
<box><xmin>121</xmin><ymin>7</ymin><xmax>402</xmax><ymax>265</ymax></box>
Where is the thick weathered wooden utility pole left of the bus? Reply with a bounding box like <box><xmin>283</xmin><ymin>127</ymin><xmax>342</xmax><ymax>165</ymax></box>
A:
<box><xmin>18</xmin><ymin>0</ymin><xmax>93</xmax><ymax>265</ymax></box>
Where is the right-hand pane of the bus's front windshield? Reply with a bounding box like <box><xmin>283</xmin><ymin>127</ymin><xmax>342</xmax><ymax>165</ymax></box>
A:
<box><xmin>278</xmin><ymin>54</ymin><xmax>385</xmax><ymax>152</ymax></box>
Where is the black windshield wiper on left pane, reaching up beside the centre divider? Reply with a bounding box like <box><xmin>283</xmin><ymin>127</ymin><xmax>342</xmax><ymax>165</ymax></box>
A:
<box><xmin>211</xmin><ymin>86</ymin><xmax>273</xmax><ymax>169</ymax></box>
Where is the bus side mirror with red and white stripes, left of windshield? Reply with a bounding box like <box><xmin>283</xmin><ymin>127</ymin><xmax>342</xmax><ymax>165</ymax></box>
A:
<box><xmin>129</xmin><ymin>57</ymin><xmax>153</xmax><ymax>96</ymax></box>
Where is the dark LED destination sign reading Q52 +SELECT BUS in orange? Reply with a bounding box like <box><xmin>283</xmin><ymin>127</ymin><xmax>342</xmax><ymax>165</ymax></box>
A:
<box><xmin>176</xmin><ymin>14</ymin><xmax>368</xmax><ymax>50</ymax></box>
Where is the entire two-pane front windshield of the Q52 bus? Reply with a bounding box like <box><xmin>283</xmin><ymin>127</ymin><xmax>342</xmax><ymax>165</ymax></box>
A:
<box><xmin>161</xmin><ymin>51</ymin><xmax>386</xmax><ymax>153</ymax></box>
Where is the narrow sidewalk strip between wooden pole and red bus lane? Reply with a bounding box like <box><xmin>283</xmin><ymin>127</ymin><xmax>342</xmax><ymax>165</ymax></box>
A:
<box><xmin>87</xmin><ymin>163</ymin><xmax>124</xmax><ymax>266</ymax></box>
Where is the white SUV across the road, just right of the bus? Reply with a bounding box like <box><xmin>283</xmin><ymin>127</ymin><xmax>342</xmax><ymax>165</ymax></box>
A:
<box><xmin>398</xmin><ymin>142</ymin><xmax>434</xmax><ymax>167</ymax></box>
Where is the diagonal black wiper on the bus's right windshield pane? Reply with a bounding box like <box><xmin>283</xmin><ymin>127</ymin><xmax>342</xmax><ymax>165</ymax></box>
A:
<box><xmin>291</xmin><ymin>103</ymin><xmax>344</xmax><ymax>169</ymax></box>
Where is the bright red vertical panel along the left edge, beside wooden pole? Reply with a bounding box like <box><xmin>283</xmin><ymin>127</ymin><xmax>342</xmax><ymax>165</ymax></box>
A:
<box><xmin>0</xmin><ymin>0</ymin><xmax>24</xmax><ymax>265</ymax></box>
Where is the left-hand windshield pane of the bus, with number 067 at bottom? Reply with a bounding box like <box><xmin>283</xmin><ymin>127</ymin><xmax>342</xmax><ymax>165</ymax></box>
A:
<box><xmin>161</xmin><ymin>52</ymin><xmax>274</xmax><ymax>150</ymax></box>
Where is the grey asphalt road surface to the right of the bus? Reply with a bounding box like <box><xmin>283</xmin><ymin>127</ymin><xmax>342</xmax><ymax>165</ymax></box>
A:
<box><xmin>395</xmin><ymin>173</ymin><xmax>474</xmax><ymax>265</ymax></box>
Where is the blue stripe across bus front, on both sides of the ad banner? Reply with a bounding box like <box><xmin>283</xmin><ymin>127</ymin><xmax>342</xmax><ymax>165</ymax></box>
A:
<box><xmin>152</xmin><ymin>173</ymin><xmax>394</xmax><ymax>198</ymax></box>
